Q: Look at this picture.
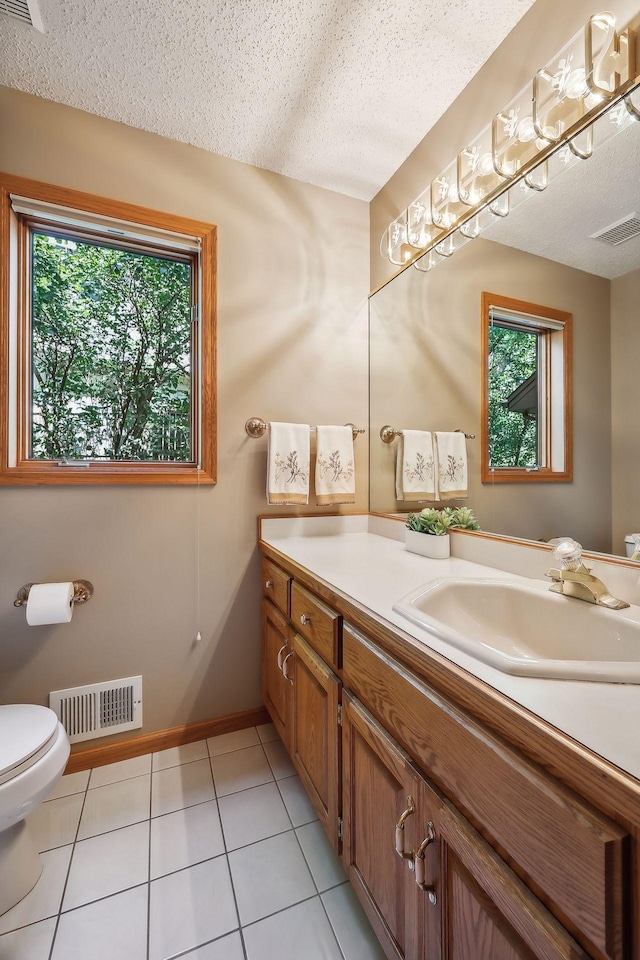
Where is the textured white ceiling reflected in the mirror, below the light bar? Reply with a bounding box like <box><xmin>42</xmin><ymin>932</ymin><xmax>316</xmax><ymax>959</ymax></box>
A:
<box><xmin>485</xmin><ymin>117</ymin><xmax>640</xmax><ymax>280</ymax></box>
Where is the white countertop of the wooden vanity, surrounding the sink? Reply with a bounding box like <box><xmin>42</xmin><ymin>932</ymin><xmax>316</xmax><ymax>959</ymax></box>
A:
<box><xmin>262</xmin><ymin>516</ymin><xmax>640</xmax><ymax>779</ymax></box>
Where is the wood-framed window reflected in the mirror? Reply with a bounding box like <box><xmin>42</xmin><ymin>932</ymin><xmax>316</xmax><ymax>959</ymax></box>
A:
<box><xmin>482</xmin><ymin>293</ymin><xmax>572</xmax><ymax>483</ymax></box>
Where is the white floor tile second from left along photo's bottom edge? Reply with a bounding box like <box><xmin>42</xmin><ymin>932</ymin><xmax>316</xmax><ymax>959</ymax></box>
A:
<box><xmin>52</xmin><ymin>884</ymin><xmax>148</xmax><ymax>960</ymax></box>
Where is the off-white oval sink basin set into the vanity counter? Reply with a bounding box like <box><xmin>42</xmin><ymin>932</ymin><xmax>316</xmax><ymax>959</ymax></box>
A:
<box><xmin>393</xmin><ymin>577</ymin><xmax>640</xmax><ymax>683</ymax></box>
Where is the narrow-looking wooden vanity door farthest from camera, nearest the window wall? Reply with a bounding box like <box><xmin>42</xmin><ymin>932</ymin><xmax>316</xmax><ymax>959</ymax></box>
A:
<box><xmin>262</xmin><ymin>600</ymin><xmax>293</xmax><ymax>748</ymax></box>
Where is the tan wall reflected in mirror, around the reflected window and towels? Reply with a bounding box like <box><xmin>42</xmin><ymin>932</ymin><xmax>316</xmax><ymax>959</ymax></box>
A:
<box><xmin>370</xmin><ymin>239</ymin><xmax>612</xmax><ymax>552</ymax></box>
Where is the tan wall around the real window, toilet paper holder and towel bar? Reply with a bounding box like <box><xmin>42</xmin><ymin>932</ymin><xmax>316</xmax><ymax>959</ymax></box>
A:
<box><xmin>0</xmin><ymin>88</ymin><xmax>369</xmax><ymax>748</ymax></box>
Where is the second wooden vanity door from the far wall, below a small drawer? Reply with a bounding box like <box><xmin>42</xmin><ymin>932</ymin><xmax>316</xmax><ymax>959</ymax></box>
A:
<box><xmin>291</xmin><ymin>634</ymin><xmax>341</xmax><ymax>852</ymax></box>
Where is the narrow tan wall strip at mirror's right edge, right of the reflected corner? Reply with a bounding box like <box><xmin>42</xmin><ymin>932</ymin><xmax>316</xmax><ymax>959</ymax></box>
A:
<box><xmin>611</xmin><ymin>270</ymin><xmax>640</xmax><ymax>554</ymax></box>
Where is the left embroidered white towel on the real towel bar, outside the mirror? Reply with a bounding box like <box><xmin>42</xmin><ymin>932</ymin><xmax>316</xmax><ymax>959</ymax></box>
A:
<box><xmin>267</xmin><ymin>423</ymin><xmax>310</xmax><ymax>503</ymax></box>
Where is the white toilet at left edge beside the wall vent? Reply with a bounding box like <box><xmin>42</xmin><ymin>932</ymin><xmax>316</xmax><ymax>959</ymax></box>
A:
<box><xmin>0</xmin><ymin>703</ymin><xmax>70</xmax><ymax>916</ymax></box>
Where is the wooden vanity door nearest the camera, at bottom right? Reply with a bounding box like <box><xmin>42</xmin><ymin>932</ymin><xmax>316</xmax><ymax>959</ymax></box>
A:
<box><xmin>415</xmin><ymin>783</ymin><xmax>589</xmax><ymax>960</ymax></box>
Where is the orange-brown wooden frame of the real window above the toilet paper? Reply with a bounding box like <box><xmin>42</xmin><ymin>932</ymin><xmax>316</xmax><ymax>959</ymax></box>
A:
<box><xmin>0</xmin><ymin>174</ymin><xmax>217</xmax><ymax>486</ymax></box>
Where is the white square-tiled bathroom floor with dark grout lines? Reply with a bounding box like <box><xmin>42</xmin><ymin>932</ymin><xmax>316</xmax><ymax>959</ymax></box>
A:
<box><xmin>0</xmin><ymin>724</ymin><xmax>383</xmax><ymax>960</ymax></box>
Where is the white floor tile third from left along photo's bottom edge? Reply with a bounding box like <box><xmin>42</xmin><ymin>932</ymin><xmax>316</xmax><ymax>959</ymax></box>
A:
<box><xmin>149</xmin><ymin>857</ymin><xmax>238</xmax><ymax>960</ymax></box>
